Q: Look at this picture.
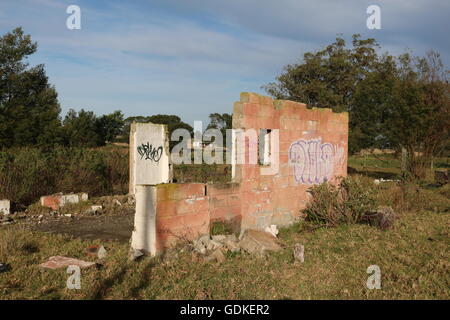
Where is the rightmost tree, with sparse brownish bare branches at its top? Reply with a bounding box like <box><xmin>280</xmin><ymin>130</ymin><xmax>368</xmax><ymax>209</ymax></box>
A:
<box><xmin>385</xmin><ymin>51</ymin><xmax>450</xmax><ymax>178</ymax></box>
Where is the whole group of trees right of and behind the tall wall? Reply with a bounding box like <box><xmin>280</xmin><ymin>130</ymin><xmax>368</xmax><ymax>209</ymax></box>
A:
<box><xmin>263</xmin><ymin>34</ymin><xmax>450</xmax><ymax>177</ymax></box>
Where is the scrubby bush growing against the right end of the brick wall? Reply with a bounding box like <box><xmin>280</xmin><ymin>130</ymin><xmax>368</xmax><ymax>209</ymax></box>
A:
<box><xmin>303</xmin><ymin>176</ymin><xmax>376</xmax><ymax>227</ymax></box>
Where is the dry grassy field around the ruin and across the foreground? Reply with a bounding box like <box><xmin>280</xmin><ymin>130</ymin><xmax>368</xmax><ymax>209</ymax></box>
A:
<box><xmin>0</xmin><ymin>156</ymin><xmax>450</xmax><ymax>299</ymax></box>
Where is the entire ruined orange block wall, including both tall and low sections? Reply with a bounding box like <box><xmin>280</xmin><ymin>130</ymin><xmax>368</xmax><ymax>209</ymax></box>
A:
<box><xmin>156</xmin><ymin>93</ymin><xmax>348</xmax><ymax>250</ymax></box>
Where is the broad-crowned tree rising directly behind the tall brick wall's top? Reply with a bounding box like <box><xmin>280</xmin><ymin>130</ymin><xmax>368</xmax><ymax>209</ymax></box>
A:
<box><xmin>263</xmin><ymin>34</ymin><xmax>379</xmax><ymax>112</ymax></box>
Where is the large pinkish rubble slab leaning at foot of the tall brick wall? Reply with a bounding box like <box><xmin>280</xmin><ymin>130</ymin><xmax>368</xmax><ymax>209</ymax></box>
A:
<box><xmin>239</xmin><ymin>229</ymin><xmax>281</xmax><ymax>255</ymax></box>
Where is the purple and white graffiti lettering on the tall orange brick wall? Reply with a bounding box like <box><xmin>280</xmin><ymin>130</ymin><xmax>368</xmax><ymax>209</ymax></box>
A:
<box><xmin>289</xmin><ymin>138</ymin><xmax>345</xmax><ymax>184</ymax></box>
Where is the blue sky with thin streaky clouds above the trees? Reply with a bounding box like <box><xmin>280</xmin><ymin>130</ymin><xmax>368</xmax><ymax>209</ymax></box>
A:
<box><xmin>0</xmin><ymin>0</ymin><xmax>450</xmax><ymax>125</ymax></box>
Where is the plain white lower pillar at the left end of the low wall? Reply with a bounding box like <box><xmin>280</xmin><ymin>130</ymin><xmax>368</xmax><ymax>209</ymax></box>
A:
<box><xmin>131</xmin><ymin>185</ymin><xmax>156</xmax><ymax>256</ymax></box>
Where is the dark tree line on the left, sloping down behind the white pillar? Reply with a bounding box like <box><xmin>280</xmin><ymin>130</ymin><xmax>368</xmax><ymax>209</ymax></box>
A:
<box><xmin>0</xmin><ymin>27</ymin><xmax>193</xmax><ymax>149</ymax></box>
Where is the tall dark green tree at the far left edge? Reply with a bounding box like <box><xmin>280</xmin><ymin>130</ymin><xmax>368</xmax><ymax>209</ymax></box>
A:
<box><xmin>0</xmin><ymin>28</ymin><xmax>61</xmax><ymax>148</ymax></box>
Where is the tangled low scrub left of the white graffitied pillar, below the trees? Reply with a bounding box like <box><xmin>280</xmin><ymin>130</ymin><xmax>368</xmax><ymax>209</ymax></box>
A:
<box><xmin>0</xmin><ymin>147</ymin><xmax>129</xmax><ymax>205</ymax></box>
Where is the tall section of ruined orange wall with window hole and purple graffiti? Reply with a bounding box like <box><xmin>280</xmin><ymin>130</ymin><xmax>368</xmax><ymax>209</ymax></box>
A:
<box><xmin>233</xmin><ymin>93</ymin><xmax>348</xmax><ymax>229</ymax></box>
